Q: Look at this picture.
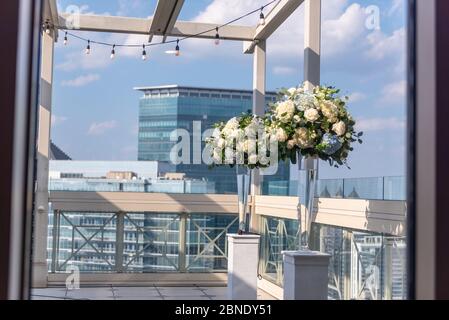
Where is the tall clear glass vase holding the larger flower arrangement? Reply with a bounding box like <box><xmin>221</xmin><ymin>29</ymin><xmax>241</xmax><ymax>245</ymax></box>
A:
<box><xmin>298</xmin><ymin>155</ymin><xmax>319</xmax><ymax>250</ymax></box>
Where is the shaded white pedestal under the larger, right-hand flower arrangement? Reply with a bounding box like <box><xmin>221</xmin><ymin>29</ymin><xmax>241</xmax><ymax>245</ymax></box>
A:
<box><xmin>283</xmin><ymin>251</ymin><xmax>330</xmax><ymax>300</ymax></box>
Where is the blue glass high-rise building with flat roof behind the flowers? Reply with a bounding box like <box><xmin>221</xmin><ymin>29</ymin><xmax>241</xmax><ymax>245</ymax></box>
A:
<box><xmin>135</xmin><ymin>85</ymin><xmax>290</xmax><ymax>193</ymax></box>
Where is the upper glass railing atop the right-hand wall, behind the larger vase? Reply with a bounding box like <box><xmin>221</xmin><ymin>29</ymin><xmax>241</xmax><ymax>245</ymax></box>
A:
<box><xmin>262</xmin><ymin>177</ymin><xmax>406</xmax><ymax>200</ymax></box>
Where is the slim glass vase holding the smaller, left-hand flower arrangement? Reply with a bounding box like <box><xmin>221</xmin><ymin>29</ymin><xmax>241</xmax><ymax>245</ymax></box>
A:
<box><xmin>236</xmin><ymin>166</ymin><xmax>251</xmax><ymax>234</ymax></box>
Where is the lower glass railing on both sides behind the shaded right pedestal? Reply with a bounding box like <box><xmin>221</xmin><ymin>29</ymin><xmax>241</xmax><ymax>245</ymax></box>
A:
<box><xmin>259</xmin><ymin>216</ymin><xmax>407</xmax><ymax>300</ymax></box>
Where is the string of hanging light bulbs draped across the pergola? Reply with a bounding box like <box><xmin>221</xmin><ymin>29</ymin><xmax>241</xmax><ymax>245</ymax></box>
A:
<box><xmin>44</xmin><ymin>0</ymin><xmax>280</xmax><ymax>61</ymax></box>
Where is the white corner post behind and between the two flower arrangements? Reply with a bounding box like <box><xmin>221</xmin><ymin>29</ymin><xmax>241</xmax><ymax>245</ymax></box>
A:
<box><xmin>250</xmin><ymin>40</ymin><xmax>267</xmax><ymax>232</ymax></box>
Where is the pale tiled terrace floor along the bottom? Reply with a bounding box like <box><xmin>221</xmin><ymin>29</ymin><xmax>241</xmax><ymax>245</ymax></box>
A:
<box><xmin>32</xmin><ymin>286</ymin><xmax>275</xmax><ymax>300</ymax></box>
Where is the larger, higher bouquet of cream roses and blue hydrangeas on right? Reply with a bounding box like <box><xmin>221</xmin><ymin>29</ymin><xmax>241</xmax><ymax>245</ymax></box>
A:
<box><xmin>265</xmin><ymin>86</ymin><xmax>363</xmax><ymax>167</ymax></box>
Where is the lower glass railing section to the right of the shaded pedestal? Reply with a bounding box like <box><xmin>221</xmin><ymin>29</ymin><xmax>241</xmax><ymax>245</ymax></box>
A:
<box><xmin>312</xmin><ymin>224</ymin><xmax>407</xmax><ymax>300</ymax></box>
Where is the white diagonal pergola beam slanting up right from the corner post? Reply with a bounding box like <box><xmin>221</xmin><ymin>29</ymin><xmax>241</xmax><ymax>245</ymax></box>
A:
<box><xmin>243</xmin><ymin>0</ymin><xmax>304</xmax><ymax>53</ymax></box>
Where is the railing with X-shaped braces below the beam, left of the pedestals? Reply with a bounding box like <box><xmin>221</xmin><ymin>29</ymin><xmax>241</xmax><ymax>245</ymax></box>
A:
<box><xmin>47</xmin><ymin>211</ymin><xmax>238</xmax><ymax>273</ymax></box>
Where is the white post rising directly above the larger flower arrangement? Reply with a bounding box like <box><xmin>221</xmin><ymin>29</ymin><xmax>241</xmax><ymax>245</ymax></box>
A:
<box><xmin>304</xmin><ymin>0</ymin><xmax>321</xmax><ymax>90</ymax></box>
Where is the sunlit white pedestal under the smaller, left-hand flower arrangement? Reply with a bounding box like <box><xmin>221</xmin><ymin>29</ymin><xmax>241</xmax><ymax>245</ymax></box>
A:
<box><xmin>228</xmin><ymin>234</ymin><xmax>260</xmax><ymax>300</ymax></box>
